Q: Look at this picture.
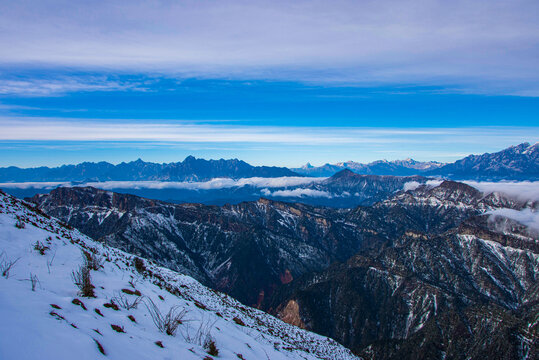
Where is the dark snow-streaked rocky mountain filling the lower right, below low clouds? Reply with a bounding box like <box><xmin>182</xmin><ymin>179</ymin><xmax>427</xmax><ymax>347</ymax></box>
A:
<box><xmin>268</xmin><ymin>181</ymin><xmax>539</xmax><ymax>359</ymax></box>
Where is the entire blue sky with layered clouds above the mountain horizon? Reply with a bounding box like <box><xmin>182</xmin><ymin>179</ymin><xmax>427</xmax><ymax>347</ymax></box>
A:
<box><xmin>0</xmin><ymin>0</ymin><xmax>539</xmax><ymax>167</ymax></box>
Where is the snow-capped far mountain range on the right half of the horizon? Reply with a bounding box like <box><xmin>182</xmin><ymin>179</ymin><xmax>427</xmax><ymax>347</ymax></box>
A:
<box><xmin>291</xmin><ymin>143</ymin><xmax>539</xmax><ymax>181</ymax></box>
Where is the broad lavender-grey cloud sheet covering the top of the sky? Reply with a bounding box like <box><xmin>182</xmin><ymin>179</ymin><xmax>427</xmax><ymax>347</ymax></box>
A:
<box><xmin>0</xmin><ymin>0</ymin><xmax>539</xmax><ymax>96</ymax></box>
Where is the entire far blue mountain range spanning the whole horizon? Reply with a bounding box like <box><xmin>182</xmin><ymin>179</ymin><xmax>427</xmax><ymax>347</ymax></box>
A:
<box><xmin>0</xmin><ymin>143</ymin><xmax>539</xmax><ymax>186</ymax></box>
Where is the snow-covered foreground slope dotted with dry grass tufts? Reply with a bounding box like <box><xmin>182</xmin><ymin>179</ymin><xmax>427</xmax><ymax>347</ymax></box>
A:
<box><xmin>0</xmin><ymin>192</ymin><xmax>356</xmax><ymax>360</ymax></box>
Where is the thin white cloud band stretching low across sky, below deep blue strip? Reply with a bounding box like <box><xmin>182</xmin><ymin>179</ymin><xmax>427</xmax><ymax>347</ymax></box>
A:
<box><xmin>0</xmin><ymin>117</ymin><xmax>539</xmax><ymax>145</ymax></box>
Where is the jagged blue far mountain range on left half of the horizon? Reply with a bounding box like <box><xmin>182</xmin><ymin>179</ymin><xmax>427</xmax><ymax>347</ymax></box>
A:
<box><xmin>0</xmin><ymin>156</ymin><xmax>299</xmax><ymax>182</ymax></box>
